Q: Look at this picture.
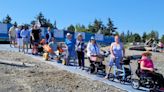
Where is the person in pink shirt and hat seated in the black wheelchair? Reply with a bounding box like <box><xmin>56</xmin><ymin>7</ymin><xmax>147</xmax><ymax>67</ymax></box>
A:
<box><xmin>137</xmin><ymin>52</ymin><xmax>164</xmax><ymax>87</ymax></box>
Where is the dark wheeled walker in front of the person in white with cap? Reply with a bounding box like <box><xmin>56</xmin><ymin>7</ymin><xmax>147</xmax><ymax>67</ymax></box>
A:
<box><xmin>89</xmin><ymin>51</ymin><xmax>110</xmax><ymax>75</ymax></box>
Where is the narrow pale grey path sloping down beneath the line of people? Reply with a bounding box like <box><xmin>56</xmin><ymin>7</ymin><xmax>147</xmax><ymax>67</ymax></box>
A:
<box><xmin>0</xmin><ymin>44</ymin><xmax>149</xmax><ymax>92</ymax></box>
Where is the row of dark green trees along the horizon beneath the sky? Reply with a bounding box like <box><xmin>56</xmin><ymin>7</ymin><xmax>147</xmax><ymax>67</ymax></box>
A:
<box><xmin>0</xmin><ymin>12</ymin><xmax>164</xmax><ymax>43</ymax></box>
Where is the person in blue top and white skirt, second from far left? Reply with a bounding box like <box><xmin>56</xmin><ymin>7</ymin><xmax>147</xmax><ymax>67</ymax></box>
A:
<box><xmin>16</xmin><ymin>26</ymin><xmax>22</xmax><ymax>52</ymax></box>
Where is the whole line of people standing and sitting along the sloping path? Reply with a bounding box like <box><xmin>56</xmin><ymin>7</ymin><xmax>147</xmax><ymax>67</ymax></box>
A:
<box><xmin>9</xmin><ymin>25</ymin><xmax>164</xmax><ymax>86</ymax></box>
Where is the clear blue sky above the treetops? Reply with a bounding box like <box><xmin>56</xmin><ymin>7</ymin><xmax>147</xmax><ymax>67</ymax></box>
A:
<box><xmin>0</xmin><ymin>0</ymin><xmax>164</xmax><ymax>36</ymax></box>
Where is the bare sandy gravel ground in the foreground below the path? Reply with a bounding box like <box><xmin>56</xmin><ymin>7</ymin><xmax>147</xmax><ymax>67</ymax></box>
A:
<box><xmin>0</xmin><ymin>51</ymin><xmax>123</xmax><ymax>92</ymax></box>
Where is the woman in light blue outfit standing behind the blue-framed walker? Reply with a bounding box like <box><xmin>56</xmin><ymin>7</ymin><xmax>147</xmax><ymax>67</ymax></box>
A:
<box><xmin>105</xmin><ymin>35</ymin><xmax>125</xmax><ymax>78</ymax></box>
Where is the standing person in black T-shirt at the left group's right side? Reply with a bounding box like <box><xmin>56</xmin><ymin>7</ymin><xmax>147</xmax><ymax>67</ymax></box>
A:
<box><xmin>32</xmin><ymin>25</ymin><xmax>41</xmax><ymax>55</ymax></box>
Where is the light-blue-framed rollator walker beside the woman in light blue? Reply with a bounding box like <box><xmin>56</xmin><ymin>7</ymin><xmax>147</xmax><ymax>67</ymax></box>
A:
<box><xmin>108</xmin><ymin>57</ymin><xmax>132</xmax><ymax>84</ymax></box>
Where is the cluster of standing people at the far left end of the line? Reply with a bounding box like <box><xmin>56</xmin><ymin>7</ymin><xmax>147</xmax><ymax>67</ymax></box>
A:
<box><xmin>8</xmin><ymin>25</ymin><xmax>53</xmax><ymax>55</ymax></box>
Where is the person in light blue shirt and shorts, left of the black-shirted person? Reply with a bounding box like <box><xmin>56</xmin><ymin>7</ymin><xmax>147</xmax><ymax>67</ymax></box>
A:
<box><xmin>21</xmin><ymin>26</ymin><xmax>30</xmax><ymax>53</ymax></box>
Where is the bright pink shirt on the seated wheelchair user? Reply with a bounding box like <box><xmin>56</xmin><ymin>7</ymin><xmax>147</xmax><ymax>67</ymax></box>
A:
<box><xmin>140</xmin><ymin>56</ymin><xmax>154</xmax><ymax>68</ymax></box>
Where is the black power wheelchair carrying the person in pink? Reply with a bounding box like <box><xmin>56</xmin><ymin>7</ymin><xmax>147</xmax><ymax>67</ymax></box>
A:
<box><xmin>131</xmin><ymin>61</ymin><xmax>163</xmax><ymax>92</ymax></box>
